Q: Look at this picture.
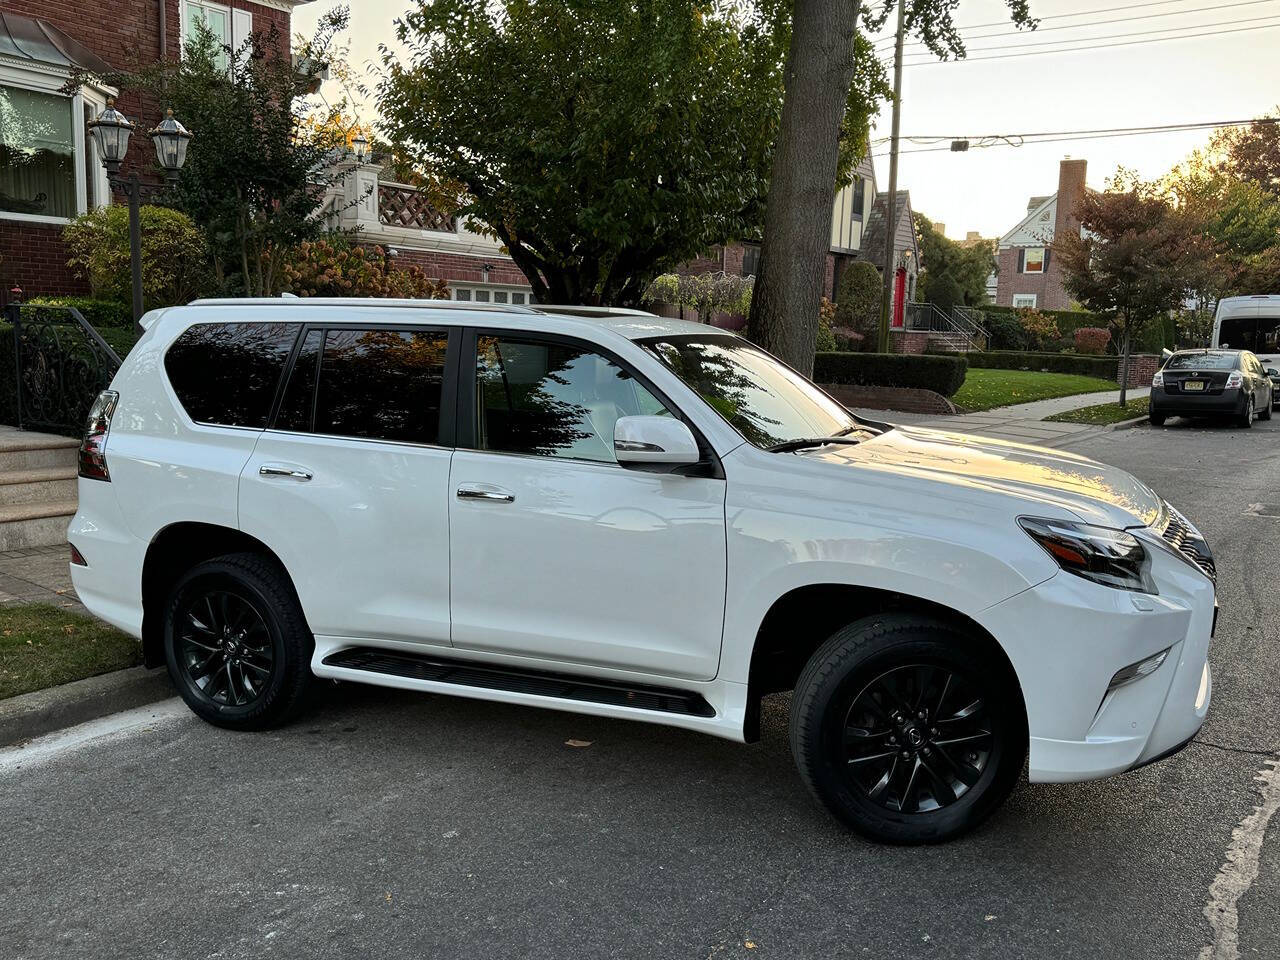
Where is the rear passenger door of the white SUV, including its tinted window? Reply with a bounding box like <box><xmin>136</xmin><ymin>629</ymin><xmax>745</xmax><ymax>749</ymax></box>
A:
<box><xmin>239</xmin><ymin>328</ymin><xmax>454</xmax><ymax>645</ymax></box>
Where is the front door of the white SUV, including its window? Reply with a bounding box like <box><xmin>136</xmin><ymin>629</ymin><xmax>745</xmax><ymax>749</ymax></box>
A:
<box><xmin>449</xmin><ymin>334</ymin><xmax>726</xmax><ymax>680</ymax></box>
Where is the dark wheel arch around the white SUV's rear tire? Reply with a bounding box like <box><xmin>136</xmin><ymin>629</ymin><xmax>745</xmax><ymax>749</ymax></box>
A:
<box><xmin>142</xmin><ymin>521</ymin><xmax>297</xmax><ymax>667</ymax></box>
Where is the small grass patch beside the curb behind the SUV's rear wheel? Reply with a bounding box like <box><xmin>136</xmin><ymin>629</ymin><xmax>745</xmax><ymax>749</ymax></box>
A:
<box><xmin>0</xmin><ymin>603</ymin><xmax>142</xmax><ymax>700</ymax></box>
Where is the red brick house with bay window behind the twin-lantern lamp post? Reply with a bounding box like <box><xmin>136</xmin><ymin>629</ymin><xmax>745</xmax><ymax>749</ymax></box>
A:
<box><xmin>0</xmin><ymin>0</ymin><xmax>302</xmax><ymax>298</ymax></box>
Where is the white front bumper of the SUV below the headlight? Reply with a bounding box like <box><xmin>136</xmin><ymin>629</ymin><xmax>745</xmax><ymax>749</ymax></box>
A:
<box><xmin>978</xmin><ymin>541</ymin><xmax>1215</xmax><ymax>782</ymax></box>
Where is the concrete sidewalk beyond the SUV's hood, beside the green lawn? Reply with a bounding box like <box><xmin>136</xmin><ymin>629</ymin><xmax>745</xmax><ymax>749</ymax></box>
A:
<box><xmin>854</xmin><ymin>387</ymin><xmax>1151</xmax><ymax>447</ymax></box>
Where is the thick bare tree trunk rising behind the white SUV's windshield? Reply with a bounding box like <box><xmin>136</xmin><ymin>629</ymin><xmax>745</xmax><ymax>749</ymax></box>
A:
<box><xmin>746</xmin><ymin>0</ymin><xmax>860</xmax><ymax>375</ymax></box>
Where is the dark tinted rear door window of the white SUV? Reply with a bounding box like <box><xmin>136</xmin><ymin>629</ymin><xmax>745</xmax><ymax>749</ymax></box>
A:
<box><xmin>315</xmin><ymin>330</ymin><xmax>449</xmax><ymax>443</ymax></box>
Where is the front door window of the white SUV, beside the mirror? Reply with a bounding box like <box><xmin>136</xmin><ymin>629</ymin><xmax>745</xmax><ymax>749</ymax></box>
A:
<box><xmin>476</xmin><ymin>337</ymin><xmax>668</xmax><ymax>463</ymax></box>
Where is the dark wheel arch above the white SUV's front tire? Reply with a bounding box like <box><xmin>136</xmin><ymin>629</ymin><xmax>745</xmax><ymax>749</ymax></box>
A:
<box><xmin>742</xmin><ymin>582</ymin><xmax>1027</xmax><ymax>742</ymax></box>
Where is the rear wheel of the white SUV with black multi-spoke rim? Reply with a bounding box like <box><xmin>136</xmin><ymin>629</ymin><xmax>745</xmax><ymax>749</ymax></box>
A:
<box><xmin>164</xmin><ymin>553</ymin><xmax>315</xmax><ymax>730</ymax></box>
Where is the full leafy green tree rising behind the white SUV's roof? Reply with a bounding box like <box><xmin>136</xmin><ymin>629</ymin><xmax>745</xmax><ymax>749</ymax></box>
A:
<box><xmin>378</xmin><ymin>0</ymin><xmax>781</xmax><ymax>303</ymax></box>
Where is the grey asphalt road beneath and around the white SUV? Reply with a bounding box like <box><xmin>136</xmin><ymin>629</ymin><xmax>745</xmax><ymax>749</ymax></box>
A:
<box><xmin>0</xmin><ymin>420</ymin><xmax>1280</xmax><ymax>960</ymax></box>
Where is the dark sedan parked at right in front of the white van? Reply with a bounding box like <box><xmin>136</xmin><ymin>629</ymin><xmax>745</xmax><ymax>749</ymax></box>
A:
<box><xmin>1151</xmin><ymin>349</ymin><xmax>1274</xmax><ymax>426</ymax></box>
